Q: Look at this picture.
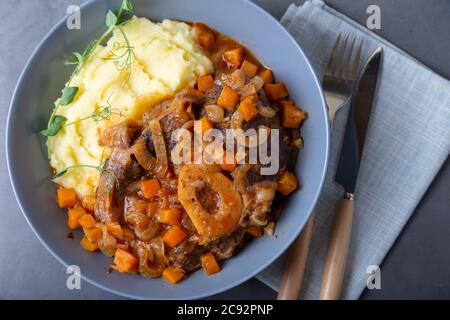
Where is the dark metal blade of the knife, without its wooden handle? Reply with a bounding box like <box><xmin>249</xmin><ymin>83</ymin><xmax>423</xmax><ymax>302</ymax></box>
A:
<box><xmin>335</xmin><ymin>47</ymin><xmax>383</xmax><ymax>197</ymax></box>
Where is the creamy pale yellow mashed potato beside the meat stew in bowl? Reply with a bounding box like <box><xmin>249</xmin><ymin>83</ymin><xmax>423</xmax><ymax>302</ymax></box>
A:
<box><xmin>48</xmin><ymin>18</ymin><xmax>213</xmax><ymax>197</ymax></box>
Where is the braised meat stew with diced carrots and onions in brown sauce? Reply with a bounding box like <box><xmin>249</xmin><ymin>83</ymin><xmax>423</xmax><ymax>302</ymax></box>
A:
<box><xmin>56</xmin><ymin>23</ymin><xmax>306</xmax><ymax>283</ymax></box>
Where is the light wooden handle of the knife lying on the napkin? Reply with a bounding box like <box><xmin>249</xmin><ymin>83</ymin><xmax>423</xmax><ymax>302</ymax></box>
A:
<box><xmin>320</xmin><ymin>195</ymin><xmax>355</xmax><ymax>300</ymax></box>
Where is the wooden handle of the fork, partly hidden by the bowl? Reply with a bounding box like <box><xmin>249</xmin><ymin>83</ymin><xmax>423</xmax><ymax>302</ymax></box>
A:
<box><xmin>277</xmin><ymin>212</ymin><xmax>315</xmax><ymax>300</ymax></box>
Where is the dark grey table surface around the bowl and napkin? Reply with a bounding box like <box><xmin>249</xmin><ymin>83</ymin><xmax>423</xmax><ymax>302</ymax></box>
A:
<box><xmin>0</xmin><ymin>0</ymin><xmax>450</xmax><ymax>299</ymax></box>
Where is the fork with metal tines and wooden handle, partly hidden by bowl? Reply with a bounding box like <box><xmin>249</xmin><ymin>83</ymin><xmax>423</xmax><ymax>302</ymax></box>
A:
<box><xmin>278</xmin><ymin>34</ymin><xmax>363</xmax><ymax>300</ymax></box>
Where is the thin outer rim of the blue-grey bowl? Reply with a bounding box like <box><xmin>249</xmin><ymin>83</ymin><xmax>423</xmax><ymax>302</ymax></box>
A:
<box><xmin>5</xmin><ymin>0</ymin><xmax>330</xmax><ymax>300</ymax></box>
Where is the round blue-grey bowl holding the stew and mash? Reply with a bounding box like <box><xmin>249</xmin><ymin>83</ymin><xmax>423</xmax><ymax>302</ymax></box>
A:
<box><xmin>6</xmin><ymin>0</ymin><xmax>328</xmax><ymax>299</ymax></box>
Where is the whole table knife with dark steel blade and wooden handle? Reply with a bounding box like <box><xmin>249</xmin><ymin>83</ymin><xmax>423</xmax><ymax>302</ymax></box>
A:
<box><xmin>320</xmin><ymin>47</ymin><xmax>383</xmax><ymax>300</ymax></box>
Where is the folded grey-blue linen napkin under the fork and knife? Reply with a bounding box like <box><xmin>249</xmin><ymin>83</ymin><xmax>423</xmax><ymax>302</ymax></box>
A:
<box><xmin>257</xmin><ymin>0</ymin><xmax>450</xmax><ymax>299</ymax></box>
